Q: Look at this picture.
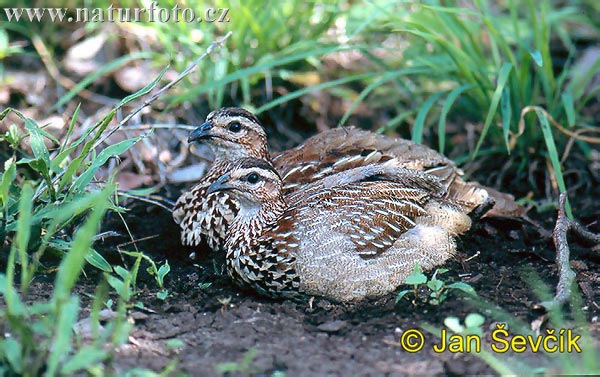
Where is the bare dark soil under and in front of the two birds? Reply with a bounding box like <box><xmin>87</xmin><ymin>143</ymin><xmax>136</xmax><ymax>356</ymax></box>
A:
<box><xmin>77</xmin><ymin>181</ymin><xmax>600</xmax><ymax>376</ymax></box>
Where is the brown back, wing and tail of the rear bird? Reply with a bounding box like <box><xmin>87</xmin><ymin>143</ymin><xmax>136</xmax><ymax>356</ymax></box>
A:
<box><xmin>273</xmin><ymin>127</ymin><xmax>526</xmax><ymax>218</ymax></box>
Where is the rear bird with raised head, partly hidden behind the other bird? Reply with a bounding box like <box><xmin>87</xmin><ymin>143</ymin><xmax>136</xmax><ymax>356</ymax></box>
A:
<box><xmin>173</xmin><ymin>107</ymin><xmax>522</xmax><ymax>252</ymax></box>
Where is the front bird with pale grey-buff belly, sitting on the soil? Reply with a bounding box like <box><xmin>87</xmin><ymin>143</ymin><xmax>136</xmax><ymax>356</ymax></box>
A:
<box><xmin>207</xmin><ymin>157</ymin><xmax>471</xmax><ymax>303</ymax></box>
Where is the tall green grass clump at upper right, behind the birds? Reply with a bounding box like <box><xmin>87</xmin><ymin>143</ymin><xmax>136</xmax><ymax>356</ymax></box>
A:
<box><xmin>328</xmin><ymin>0</ymin><xmax>600</xmax><ymax>213</ymax></box>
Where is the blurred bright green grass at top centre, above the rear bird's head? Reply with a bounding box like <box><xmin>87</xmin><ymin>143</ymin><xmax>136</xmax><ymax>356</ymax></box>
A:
<box><xmin>155</xmin><ymin>0</ymin><xmax>343</xmax><ymax>108</ymax></box>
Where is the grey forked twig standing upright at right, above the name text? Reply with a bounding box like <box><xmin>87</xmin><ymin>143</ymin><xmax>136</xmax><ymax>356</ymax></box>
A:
<box><xmin>539</xmin><ymin>192</ymin><xmax>600</xmax><ymax>310</ymax></box>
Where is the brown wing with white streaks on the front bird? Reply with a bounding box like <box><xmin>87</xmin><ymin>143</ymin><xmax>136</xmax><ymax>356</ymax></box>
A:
<box><xmin>279</xmin><ymin>164</ymin><xmax>445</xmax><ymax>258</ymax></box>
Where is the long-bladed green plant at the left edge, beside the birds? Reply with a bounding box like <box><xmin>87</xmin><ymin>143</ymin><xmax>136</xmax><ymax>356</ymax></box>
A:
<box><xmin>0</xmin><ymin>108</ymin><xmax>140</xmax><ymax>292</ymax></box>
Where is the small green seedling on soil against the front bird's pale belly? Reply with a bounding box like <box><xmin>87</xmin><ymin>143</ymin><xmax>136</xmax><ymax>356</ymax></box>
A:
<box><xmin>396</xmin><ymin>263</ymin><xmax>475</xmax><ymax>305</ymax></box>
